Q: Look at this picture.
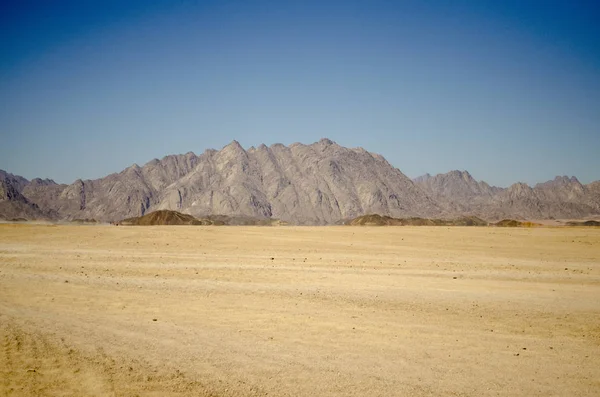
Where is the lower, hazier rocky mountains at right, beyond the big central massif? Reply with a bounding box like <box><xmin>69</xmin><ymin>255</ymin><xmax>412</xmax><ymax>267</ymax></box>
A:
<box><xmin>414</xmin><ymin>171</ymin><xmax>600</xmax><ymax>220</ymax></box>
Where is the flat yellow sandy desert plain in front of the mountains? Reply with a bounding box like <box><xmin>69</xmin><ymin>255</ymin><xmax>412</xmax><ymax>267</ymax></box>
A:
<box><xmin>0</xmin><ymin>225</ymin><xmax>600</xmax><ymax>396</ymax></box>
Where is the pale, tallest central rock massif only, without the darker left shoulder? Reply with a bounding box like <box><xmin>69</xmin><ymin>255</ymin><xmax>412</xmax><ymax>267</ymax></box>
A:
<box><xmin>158</xmin><ymin>139</ymin><xmax>442</xmax><ymax>224</ymax></box>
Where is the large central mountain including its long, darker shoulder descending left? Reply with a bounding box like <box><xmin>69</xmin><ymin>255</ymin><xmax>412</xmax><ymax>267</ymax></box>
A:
<box><xmin>4</xmin><ymin>139</ymin><xmax>446</xmax><ymax>224</ymax></box>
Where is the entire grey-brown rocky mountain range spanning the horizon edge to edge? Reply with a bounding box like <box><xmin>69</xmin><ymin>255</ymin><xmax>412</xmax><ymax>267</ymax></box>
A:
<box><xmin>0</xmin><ymin>139</ymin><xmax>600</xmax><ymax>225</ymax></box>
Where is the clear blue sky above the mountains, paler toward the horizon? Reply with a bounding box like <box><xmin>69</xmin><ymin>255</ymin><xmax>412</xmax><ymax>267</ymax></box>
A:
<box><xmin>0</xmin><ymin>0</ymin><xmax>600</xmax><ymax>186</ymax></box>
